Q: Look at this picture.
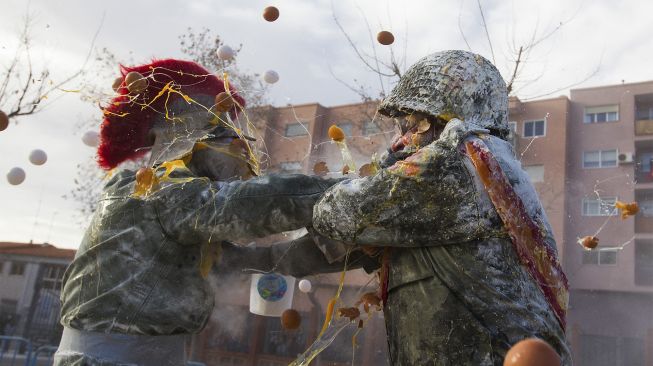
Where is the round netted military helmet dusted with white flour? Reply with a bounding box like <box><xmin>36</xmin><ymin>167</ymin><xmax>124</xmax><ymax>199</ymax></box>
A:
<box><xmin>379</xmin><ymin>50</ymin><xmax>509</xmax><ymax>138</ymax></box>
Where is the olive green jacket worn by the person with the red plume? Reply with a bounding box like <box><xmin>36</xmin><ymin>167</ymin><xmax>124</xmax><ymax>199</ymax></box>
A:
<box><xmin>61</xmin><ymin>169</ymin><xmax>336</xmax><ymax>335</ymax></box>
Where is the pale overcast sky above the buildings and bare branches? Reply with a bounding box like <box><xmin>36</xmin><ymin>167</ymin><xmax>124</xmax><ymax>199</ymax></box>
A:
<box><xmin>0</xmin><ymin>0</ymin><xmax>653</xmax><ymax>248</ymax></box>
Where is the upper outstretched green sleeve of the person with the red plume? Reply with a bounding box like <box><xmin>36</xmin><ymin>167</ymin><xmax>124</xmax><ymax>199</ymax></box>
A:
<box><xmin>154</xmin><ymin>174</ymin><xmax>338</xmax><ymax>245</ymax></box>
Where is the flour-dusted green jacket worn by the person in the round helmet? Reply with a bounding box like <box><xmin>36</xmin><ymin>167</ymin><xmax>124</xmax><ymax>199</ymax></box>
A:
<box><xmin>313</xmin><ymin>120</ymin><xmax>570</xmax><ymax>365</ymax></box>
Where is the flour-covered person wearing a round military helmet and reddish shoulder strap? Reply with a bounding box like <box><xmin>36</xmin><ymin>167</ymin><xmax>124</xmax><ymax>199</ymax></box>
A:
<box><xmin>268</xmin><ymin>51</ymin><xmax>571</xmax><ymax>366</ymax></box>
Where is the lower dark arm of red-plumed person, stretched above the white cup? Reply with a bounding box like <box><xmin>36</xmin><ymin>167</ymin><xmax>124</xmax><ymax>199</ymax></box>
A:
<box><xmin>216</xmin><ymin>234</ymin><xmax>379</xmax><ymax>278</ymax></box>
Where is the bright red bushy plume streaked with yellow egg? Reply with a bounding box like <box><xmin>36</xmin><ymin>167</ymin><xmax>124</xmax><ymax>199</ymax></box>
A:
<box><xmin>98</xmin><ymin>59</ymin><xmax>245</xmax><ymax>170</ymax></box>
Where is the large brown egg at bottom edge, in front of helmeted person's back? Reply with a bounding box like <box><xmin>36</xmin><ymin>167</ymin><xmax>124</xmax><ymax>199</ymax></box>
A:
<box><xmin>503</xmin><ymin>338</ymin><xmax>560</xmax><ymax>366</ymax></box>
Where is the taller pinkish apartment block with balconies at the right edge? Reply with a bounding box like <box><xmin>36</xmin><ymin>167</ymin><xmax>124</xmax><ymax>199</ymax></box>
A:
<box><xmin>564</xmin><ymin>82</ymin><xmax>653</xmax><ymax>366</ymax></box>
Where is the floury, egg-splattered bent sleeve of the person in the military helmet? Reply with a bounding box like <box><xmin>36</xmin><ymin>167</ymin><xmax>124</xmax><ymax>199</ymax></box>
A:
<box><xmin>313</xmin><ymin>141</ymin><xmax>482</xmax><ymax>247</ymax></box>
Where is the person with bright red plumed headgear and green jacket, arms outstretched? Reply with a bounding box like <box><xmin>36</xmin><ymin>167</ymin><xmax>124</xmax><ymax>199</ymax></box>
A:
<box><xmin>55</xmin><ymin>60</ymin><xmax>348</xmax><ymax>365</ymax></box>
